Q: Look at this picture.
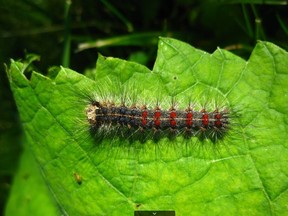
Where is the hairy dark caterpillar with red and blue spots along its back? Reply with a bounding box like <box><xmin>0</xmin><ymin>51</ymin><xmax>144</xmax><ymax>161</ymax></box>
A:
<box><xmin>86</xmin><ymin>101</ymin><xmax>229</xmax><ymax>141</ymax></box>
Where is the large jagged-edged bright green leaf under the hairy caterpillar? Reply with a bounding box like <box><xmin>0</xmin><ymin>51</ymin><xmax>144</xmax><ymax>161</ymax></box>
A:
<box><xmin>8</xmin><ymin>38</ymin><xmax>288</xmax><ymax>215</ymax></box>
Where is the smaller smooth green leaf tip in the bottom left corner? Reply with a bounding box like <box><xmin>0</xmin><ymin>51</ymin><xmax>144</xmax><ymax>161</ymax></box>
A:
<box><xmin>5</xmin><ymin>143</ymin><xmax>60</xmax><ymax>216</ymax></box>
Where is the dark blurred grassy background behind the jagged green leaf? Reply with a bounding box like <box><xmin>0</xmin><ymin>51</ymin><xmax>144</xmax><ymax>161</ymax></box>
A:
<box><xmin>0</xmin><ymin>0</ymin><xmax>288</xmax><ymax>212</ymax></box>
